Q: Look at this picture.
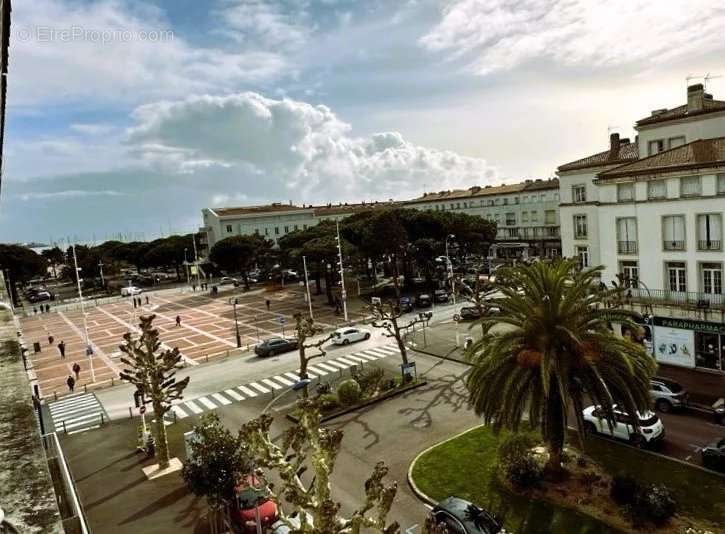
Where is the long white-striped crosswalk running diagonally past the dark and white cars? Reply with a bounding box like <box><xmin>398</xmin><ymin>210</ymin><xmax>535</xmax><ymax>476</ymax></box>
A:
<box><xmin>171</xmin><ymin>345</ymin><xmax>400</xmax><ymax>419</ymax></box>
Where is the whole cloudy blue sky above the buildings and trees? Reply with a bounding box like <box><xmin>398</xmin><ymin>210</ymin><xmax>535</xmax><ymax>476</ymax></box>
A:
<box><xmin>0</xmin><ymin>0</ymin><xmax>725</xmax><ymax>242</ymax></box>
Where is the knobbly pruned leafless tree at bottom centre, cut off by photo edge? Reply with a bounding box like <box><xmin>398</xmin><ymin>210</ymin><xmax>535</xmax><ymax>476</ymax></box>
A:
<box><xmin>239</xmin><ymin>399</ymin><xmax>400</xmax><ymax>534</ymax></box>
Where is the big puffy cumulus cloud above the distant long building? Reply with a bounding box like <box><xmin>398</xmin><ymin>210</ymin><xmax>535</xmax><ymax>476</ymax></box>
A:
<box><xmin>128</xmin><ymin>92</ymin><xmax>496</xmax><ymax>202</ymax></box>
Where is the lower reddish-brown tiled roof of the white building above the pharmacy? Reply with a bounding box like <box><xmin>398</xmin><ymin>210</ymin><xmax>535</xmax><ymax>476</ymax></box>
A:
<box><xmin>598</xmin><ymin>137</ymin><xmax>725</xmax><ymax>180</ymax></box>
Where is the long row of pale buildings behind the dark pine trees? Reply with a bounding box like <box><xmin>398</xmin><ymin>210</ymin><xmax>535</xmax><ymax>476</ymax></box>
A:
<box><xmin>200</xmin><ymin>179</ymin><xmax>561</xmax><ymax>257</ymax></box>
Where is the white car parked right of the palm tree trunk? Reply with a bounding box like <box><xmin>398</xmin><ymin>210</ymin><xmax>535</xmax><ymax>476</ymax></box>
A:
<box><xmin>583</xmin><ymin>405</ymin><xmax>665</xmax><ymax>447</ymax></box>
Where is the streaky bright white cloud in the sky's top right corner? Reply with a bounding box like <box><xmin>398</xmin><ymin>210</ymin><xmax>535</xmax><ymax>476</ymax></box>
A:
<box><xmin>419</xmin><ymin>0</ymin><xmax>725</xmax><ymax>75</ymax></box>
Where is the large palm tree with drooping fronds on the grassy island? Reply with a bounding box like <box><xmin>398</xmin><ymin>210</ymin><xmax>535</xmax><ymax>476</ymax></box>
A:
<box><xmin>467</xmin><ymin>260</ymin><xmax>656</xmax><ymax>473</ymax></box>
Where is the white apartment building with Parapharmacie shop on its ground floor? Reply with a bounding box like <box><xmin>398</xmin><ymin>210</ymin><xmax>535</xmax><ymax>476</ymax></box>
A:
<box><xmin>558</xmin><ymin>84</ymin><xmax>725</xmax><ymax>371</ymax></box>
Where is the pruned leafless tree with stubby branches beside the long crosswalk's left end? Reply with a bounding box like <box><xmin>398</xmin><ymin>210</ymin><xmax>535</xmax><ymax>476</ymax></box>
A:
<box><xmin>119</xmin><ymin>315</ymin><xmax>189</xmax><ymax>469</ymax></box>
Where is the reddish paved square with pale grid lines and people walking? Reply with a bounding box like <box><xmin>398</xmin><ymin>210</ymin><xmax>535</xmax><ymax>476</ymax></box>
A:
<box><xmin>20</xmin><ymin>286</ymin><xmax>353</xmax><ymax>396</ymax></box>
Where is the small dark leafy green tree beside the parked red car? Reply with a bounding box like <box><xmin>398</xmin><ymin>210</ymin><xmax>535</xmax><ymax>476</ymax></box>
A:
<box><xmin>181</xmin><ymin>412</ymin><xmax>254</xmax><ymax>513</ymax></box>
